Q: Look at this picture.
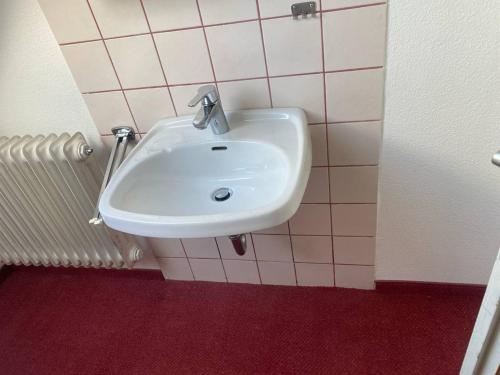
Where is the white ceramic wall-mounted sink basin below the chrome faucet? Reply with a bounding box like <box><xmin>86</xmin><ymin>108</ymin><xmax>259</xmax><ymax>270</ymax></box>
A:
<box><xmin>99</xmin><ymin>108</ymin><xmax>311</xmax><ymax>238</ymax></box>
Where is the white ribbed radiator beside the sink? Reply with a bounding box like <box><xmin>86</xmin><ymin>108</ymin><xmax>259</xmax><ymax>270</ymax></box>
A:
<box><xmin>0</xmin><ymin>133</ymin><xmax>142</xmax><ymax>268</ymax></box>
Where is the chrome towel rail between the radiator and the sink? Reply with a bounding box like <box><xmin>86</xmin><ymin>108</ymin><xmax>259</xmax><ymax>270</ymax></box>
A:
<box><xmin>89</xmin><ymin>126</ymin><xmax>135</xmax><ymax>225</ymax></box>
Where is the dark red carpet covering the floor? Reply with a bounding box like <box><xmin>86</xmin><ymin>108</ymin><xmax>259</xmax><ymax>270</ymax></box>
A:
<box><xmin>0</xmin><ymin>268</ymin><xmax>481</xmax><ymax>375</ymax></box>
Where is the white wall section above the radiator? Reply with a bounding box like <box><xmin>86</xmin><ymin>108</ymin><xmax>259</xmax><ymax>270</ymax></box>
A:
<box><xmin>0</xmin><ymin>0</ymin><xmax>101</xmax><ymax>147</ymax></box>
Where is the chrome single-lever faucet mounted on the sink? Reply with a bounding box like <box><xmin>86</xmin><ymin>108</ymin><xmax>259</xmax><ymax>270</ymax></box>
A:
<box><xmin>188</xmin><ymin>85</ymin><xmax>230</xmax><ymax>134</ymax></box>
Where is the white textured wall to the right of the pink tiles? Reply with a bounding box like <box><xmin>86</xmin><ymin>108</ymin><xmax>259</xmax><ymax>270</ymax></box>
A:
<box><xmin>376</xmin><ymin>0</ymin><xmax>500</xmax><ymax>283</ymax></box>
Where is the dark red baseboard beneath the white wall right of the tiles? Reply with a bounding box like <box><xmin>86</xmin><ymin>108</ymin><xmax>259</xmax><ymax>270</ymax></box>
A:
<box><xmin>375</xmin><ymin>280</ymin><xmax>486</xmax><ymax>297</ymax></box>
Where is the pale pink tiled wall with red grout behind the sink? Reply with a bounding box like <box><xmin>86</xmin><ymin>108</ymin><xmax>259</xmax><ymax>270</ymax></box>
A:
<box><xmin>39</xmin><ymin>0</ymin><xmax>386</xmax><ymax>289</ymax></box>
